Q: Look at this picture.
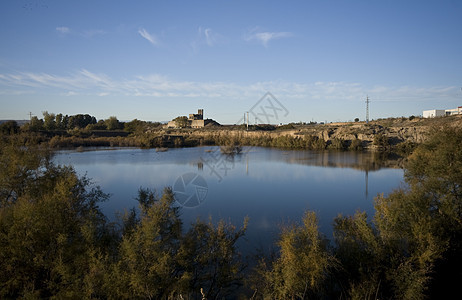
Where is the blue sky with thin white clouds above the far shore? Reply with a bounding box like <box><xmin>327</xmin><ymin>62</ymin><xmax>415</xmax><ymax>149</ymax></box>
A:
<box><xmin>0</xmin><ymin>0</ymin><xmax>462</xmax><ymax>124</ymax></box>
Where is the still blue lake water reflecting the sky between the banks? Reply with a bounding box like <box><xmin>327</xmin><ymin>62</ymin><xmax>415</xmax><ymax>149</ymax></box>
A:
<box><xmin>54</xmin><ymin>147</ymin><xmax>403</xmax><ymax>251</ymax></box>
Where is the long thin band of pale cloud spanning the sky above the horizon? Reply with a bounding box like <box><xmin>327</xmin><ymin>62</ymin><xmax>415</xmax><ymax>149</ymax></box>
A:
<box><xmin>0</xmin><ymin>69</ymin><xmax>460</xmax><ymax>102</ymax></box>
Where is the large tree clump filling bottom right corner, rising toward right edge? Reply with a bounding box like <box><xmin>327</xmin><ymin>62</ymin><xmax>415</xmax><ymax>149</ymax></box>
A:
<box><xmin>334</xmin><ymin>128</ymin><xmax>462</xmax><ymax>299</ymax></box>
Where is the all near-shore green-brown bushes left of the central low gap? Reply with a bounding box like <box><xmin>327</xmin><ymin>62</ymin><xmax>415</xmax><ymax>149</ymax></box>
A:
<box><xmin>0</xmin><ymin>136</ymin><xmax>247</xmax><ymax>299</ymax></box>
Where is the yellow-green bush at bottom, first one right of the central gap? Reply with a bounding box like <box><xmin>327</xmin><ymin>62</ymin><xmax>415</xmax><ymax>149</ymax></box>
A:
<box><xmin>257</xmin><ymin>212</ymin><xmax>336</xmax><ymax>299</ymax></box>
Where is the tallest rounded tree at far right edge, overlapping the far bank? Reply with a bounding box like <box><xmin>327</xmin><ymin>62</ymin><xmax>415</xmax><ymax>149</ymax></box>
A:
<box><xmin>405</xmin><ymin>127</ymin><xmax>462</xmax><ymax>296</ymax></box>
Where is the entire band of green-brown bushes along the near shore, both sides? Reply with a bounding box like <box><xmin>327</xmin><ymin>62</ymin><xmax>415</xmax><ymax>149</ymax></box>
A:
<box><xmin>0</xmin><ymin>128</ymin><xmax>462</xmax><ymax>299</ymax></box>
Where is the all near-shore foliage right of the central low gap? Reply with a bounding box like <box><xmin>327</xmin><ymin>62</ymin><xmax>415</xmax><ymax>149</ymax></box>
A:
<box><xmin>251</xmin><ymin>128</ymin><xmax>462</xmax><ymax>299</ymax></box>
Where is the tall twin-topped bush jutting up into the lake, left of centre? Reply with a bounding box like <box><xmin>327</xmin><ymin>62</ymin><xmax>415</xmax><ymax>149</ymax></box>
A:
<box><xmin>117</xmin><ymin>189</ymin><xmax>182</xmax><ymax>299</ymax></box>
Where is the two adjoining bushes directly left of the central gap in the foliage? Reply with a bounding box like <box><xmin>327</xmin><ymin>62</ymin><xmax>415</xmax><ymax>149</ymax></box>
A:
<box><xmin>112</xmin><ymin>189</ymin><xmax>247</xmax><ymax>299</ymax></box>
